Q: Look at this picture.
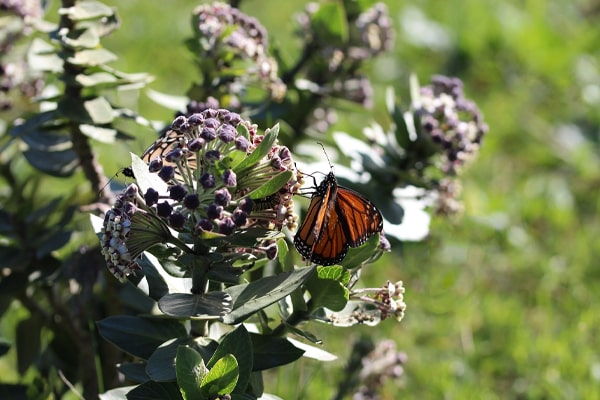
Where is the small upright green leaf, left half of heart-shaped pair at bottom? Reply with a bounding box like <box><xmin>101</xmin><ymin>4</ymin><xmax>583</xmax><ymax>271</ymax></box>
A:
<box><xmin>175</xmin><ymin>346</ymin><xmax>208</xmax><ymax>400</ymax></box>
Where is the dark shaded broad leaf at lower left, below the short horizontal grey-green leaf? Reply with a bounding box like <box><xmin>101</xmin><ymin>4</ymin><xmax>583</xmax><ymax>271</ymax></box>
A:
<box><xmin>96</xmin><ymin>315</ymin><xmax>187</xmax><ymax>360</ymax></box>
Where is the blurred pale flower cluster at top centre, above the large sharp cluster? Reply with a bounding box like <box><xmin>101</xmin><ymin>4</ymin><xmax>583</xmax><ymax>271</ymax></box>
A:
<box><xmin>193</xmin><ymin>2</ymin><xmax>286</xmax><ymax>99</ymax></box>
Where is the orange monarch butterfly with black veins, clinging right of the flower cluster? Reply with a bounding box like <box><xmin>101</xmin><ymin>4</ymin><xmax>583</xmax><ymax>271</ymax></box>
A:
<box><xmin>294</xmin><ymin>172</ymin><xmax>383</xmax><ymax>265</ymax></box>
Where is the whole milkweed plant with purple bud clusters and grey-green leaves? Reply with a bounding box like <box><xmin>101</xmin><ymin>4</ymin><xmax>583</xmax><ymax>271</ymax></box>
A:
<box><xmin>0</xmin><ymin>1</ymin><xmax>487</xmax><ymax>399</ymax></box>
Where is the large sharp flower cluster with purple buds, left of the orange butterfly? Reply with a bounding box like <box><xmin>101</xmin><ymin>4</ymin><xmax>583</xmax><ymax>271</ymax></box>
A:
<box><xmin>102</xmin><ymin>109</ymin><xmax>300</xmax><ymax>279</ymax></box>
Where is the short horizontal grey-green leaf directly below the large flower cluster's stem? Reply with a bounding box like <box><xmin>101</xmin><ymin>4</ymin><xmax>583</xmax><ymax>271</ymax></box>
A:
<box><xmin>158</xmin><ymin>292</ymin><xmax>231</xmax><ymax>319</ymax></box>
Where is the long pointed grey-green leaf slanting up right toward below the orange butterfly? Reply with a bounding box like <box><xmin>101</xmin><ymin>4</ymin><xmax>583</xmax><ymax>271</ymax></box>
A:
<box><xmin>223</xmin><ymin>266</ymin><xmax>315</xmax><ymax>324</ymax></box>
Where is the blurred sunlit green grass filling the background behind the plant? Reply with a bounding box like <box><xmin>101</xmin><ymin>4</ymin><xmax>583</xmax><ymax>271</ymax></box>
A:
<box><xmin>36</xmin><ymin>0</ymin><xmax>600</xmax><ymax>399</ymax></box>
